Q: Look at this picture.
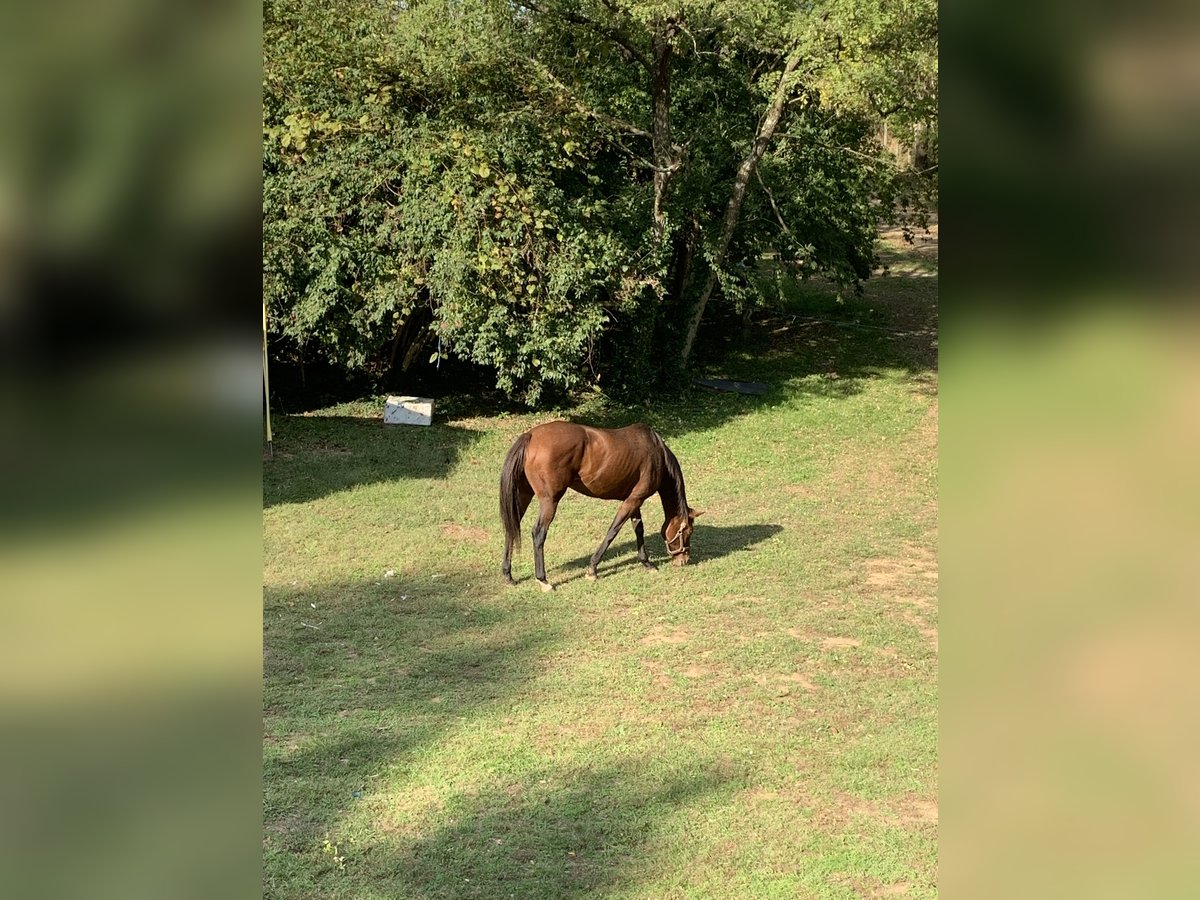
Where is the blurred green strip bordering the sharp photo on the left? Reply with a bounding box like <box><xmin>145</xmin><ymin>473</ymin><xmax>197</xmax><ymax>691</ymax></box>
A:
<box><xmin>0</xmin><ymin>0</ymin><xmax>262</xmax><ymax>898</ymax></box>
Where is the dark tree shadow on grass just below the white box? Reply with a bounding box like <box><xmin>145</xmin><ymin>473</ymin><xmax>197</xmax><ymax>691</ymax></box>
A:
<box><xmin>263</xmin><ymin>415</ymin><xmax>487</xmax><ymax>508</ymax></box>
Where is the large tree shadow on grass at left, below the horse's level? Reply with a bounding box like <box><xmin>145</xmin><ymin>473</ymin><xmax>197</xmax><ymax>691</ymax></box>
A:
<box><xmin>263</xmin><ymin>578</ymin><xmax>556</xmax><ymax>871</ymax></box>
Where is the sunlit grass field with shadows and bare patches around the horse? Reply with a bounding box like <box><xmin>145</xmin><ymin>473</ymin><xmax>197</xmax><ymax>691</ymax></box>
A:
<box><xmin>263</xmin><ymin>226</ymin><xmax>937</xmax><ymax>900</ymax></box>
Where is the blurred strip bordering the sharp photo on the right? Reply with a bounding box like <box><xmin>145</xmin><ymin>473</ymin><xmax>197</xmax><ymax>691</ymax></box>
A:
<box><xmin>940</xmin><ymin>2</ymin><xmax>1200</xmax><ymax>898</ymax></box>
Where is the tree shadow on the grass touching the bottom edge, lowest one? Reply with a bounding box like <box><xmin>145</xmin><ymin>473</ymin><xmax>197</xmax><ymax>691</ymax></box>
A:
<box><xmin>366</xmin><ymin>761</ymin><xmax>731</xmax><ymax>900</ymax></box>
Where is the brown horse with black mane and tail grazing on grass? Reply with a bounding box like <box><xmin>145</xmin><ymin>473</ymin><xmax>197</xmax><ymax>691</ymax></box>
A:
<box><xmin>500</xmin><ymin>422</ymin><xmax>701</xmax><ymax>590</ymax></box>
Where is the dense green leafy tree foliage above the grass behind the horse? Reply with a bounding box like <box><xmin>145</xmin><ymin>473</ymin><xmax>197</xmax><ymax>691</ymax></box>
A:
<box><xmin>263</xmin><ymin>0</ymin><xmax>936</xmax><ymax>403</ymax></box>
